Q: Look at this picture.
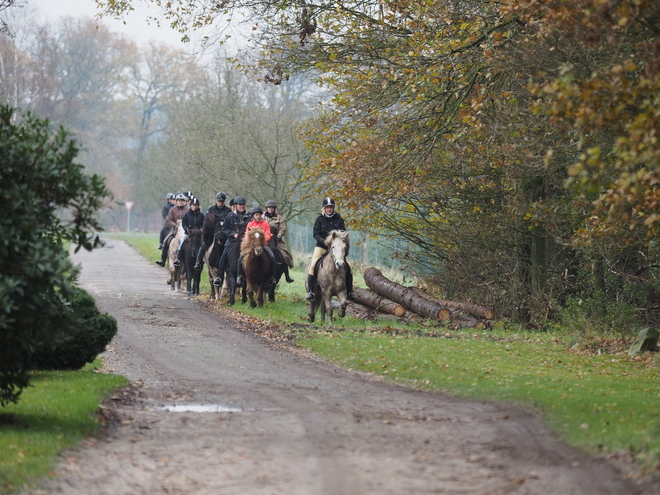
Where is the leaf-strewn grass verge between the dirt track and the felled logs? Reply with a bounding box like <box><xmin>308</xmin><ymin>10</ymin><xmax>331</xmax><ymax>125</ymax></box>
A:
<box><xmin>299</xmin><ymin>333</ymin><xmax>660</xmax><ymax>466</ymax></box>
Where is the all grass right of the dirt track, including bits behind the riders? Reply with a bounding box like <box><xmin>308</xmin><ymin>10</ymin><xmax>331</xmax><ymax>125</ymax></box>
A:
<box><xmin>111</xmin><ymin>232</ymin><xmax>660</xmax><ymax>471</ymax></box>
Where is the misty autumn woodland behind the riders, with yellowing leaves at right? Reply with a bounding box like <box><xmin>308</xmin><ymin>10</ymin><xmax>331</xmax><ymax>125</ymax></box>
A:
<box><xmin>0</xmin><ymin>0</ymin><xmax>660</xmax><ymax>335</ymax></box>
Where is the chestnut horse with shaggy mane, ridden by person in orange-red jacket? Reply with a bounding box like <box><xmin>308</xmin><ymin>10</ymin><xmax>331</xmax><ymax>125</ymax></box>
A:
<box><xmin>241</xmin><ymin>227</ymin><xmax>271</xmax><ymax>308</ymax></box>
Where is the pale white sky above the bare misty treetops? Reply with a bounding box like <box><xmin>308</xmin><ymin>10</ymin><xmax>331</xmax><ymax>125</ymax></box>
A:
<box><xmin>28</xmin><ymin>0</ymin><xmax>204</xmax><ymax>51</ymax></box>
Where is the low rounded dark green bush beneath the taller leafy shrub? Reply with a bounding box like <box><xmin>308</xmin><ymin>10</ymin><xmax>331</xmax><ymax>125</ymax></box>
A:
<box><xmin>30</xmin><ymin>289</ymin><xmax>117</xmax><ymax>370</ymax></box>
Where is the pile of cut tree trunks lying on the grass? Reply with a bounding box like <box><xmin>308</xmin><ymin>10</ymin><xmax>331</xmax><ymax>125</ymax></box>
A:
<box><xmin>348</xmin><ymin>267</ymin><xmax>493</xmax><ymax>328</ymax></box>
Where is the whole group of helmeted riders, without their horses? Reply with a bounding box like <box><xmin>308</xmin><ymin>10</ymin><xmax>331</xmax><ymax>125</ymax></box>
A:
<box><xmin>156</xmin><ymin>191</ymin><xmax>356</xmax><ymax>301</ymax></box>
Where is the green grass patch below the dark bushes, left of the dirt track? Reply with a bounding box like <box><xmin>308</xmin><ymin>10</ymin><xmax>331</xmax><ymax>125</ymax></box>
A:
<box><xmin>0</xmin><ymin>362</ymin><xmax>127</xmax><ymax>495</ymax></box>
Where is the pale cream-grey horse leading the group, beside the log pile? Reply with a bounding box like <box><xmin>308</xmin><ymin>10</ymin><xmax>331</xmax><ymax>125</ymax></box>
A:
<box><xmin>307</xmin><ymin>230</ymin><xmax>350</xmax><ymax>324</ymax></box>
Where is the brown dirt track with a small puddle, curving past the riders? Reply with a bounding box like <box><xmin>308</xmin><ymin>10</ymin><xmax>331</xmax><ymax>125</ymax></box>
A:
<box><xmin>25</xmin><ymin>241</ymin><xmax>636</xmax><ymax>495</ymax></box>
